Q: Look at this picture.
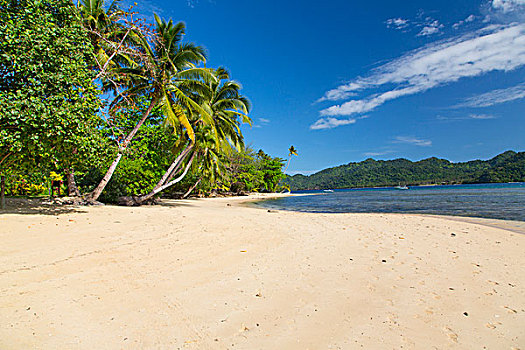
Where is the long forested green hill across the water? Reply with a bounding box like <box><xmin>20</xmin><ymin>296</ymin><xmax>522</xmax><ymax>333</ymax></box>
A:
<box><xmin>286</xmin><ymin>151</ymin><xmax>525</xmax><ymax>190</ymax></box>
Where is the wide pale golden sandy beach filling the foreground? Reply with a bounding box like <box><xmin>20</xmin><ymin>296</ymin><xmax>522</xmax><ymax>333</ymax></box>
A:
<box><xmin>0</xmin><ymin>195</ymin><xmax>525</xmax><ymax>349</ymax></box>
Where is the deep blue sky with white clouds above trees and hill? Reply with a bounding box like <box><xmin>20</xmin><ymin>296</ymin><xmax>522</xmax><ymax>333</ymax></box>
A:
<box><xmin>124</xmin><ymin>0</ymin><xmax>525</xmax><ymax>175</ymax></box>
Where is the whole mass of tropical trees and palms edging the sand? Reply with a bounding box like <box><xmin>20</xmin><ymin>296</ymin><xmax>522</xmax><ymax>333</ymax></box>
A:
<box><xmin>0</xmin><ymin>0</ymin><xmax>284</xmax><ymax>205</ymax></box>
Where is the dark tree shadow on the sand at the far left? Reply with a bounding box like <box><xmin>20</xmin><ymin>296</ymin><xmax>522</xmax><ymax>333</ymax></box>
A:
<box><xmin>0</xmin><ymin>198</ymin><xmax>86</xmax><ymax>215</ymax></box>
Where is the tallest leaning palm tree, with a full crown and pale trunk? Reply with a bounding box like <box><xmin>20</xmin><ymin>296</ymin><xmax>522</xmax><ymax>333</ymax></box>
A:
<box><xmin>89</xmin><ymin>15</ymin><xmax>214</xmax><ymax>201</ymax></box>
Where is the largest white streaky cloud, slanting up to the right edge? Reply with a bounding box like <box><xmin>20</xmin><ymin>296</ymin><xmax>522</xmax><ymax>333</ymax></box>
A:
<box><xmin>321</xmin><ymin>24</ymin><xmax>525</xmax><ymax>116</ymax></box>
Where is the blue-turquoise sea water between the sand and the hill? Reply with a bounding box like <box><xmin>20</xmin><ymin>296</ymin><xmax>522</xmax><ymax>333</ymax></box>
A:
<box><xmin>255</xmin><ymin>182</ymin><xmax>525</xmax><ymax>221</ymax></box>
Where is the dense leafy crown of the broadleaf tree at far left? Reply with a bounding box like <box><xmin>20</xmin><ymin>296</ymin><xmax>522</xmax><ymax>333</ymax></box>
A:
<box><xmin>0</xmin><ymin>0</ymin><xmax>103</xmax><ymax>171</ymax></box>
